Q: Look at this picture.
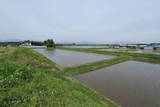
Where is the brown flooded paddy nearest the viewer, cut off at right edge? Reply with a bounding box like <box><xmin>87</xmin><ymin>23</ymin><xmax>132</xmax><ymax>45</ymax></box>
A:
<box><xmin>74</xmin><ymin>61</ymin><xmax>160</xmax><ymax>107</ymax></box>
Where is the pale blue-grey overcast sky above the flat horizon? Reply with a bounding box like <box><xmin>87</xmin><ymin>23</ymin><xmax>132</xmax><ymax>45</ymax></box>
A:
<box><xmin>0</xmin><ymin>0</ymin><xmax>160</xmax><ymax>43</ymax></box>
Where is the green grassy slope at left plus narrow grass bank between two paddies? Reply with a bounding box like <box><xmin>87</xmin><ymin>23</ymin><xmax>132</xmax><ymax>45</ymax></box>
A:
<box><xmin>0</xmin><ymin>47</ymin><xmax>120</xmax><ymax>107</ymax></box>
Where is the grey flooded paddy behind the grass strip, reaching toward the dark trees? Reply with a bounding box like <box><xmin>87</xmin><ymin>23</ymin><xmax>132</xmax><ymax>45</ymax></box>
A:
<box><xmin>35</xmin><ymin>49</ymin><xmax>114</xmax><ymax>67</ymax></box>
